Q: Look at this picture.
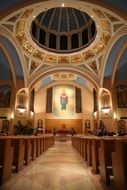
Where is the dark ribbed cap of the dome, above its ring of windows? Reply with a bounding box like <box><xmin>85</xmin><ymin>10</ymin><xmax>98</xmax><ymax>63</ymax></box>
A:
<box><xmin>34</xmin><ymin>7</ymin><xmax>92</xmax><ymax>34</ymax></box>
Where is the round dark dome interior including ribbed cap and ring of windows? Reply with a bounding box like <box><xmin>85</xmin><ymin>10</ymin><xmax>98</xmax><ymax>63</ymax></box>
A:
<box><xmin>31</xmin><ymin>7</ymin><xmax>96</xmax><ymax>53</ymax></box>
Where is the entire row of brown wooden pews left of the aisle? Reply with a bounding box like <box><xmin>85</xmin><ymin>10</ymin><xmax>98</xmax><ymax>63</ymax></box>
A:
<box><xmin>0</xmin><ymin>135</ymin><xmax>55</xmax><ymax>185</ymax></box>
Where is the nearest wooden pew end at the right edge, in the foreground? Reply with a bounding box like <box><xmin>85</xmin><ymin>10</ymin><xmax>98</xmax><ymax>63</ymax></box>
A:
<box><xmin>112</xmin><ymin>140</ymin><xmax>127</xmax><ymax>190</ymax></box>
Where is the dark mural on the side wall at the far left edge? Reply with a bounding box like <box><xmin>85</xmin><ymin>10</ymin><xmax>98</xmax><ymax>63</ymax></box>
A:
<box><xmin>0</xmin><ymin>85</ymin><xmax>12</xmax><ymax>108</ymax></box>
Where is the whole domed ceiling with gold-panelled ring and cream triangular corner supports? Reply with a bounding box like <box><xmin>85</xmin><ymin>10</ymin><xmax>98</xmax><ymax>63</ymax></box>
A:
<box><xmin>0</xmin><ymin>0</ymin><xmax>126</xmax><ymax>85</ymax></box>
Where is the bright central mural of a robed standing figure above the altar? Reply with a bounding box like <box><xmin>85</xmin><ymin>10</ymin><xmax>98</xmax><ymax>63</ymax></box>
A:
<box><xmin>53</xmin><ymin>85</ymin><xmax>74</xmax><ymax>118</ymax></box>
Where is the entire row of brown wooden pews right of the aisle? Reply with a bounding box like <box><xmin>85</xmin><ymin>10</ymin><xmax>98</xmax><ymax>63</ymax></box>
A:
<box><xmin>72</xmin><ymin>136</ymin><xmax>127</xmax><ymax>190</ymax></box>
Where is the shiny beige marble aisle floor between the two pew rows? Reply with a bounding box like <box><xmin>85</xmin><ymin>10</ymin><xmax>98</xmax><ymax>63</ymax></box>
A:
<box><xmin>0</xmin><ymin>142</ymin><xmax>109</xmax><ymax>190</ymax></box>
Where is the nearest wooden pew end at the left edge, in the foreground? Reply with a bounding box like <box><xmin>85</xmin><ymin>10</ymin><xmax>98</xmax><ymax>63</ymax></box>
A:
<box><xmin>0</xmin><ymin>137</ymin><xmax>13</xmax><ymax>184</ymax></box>
